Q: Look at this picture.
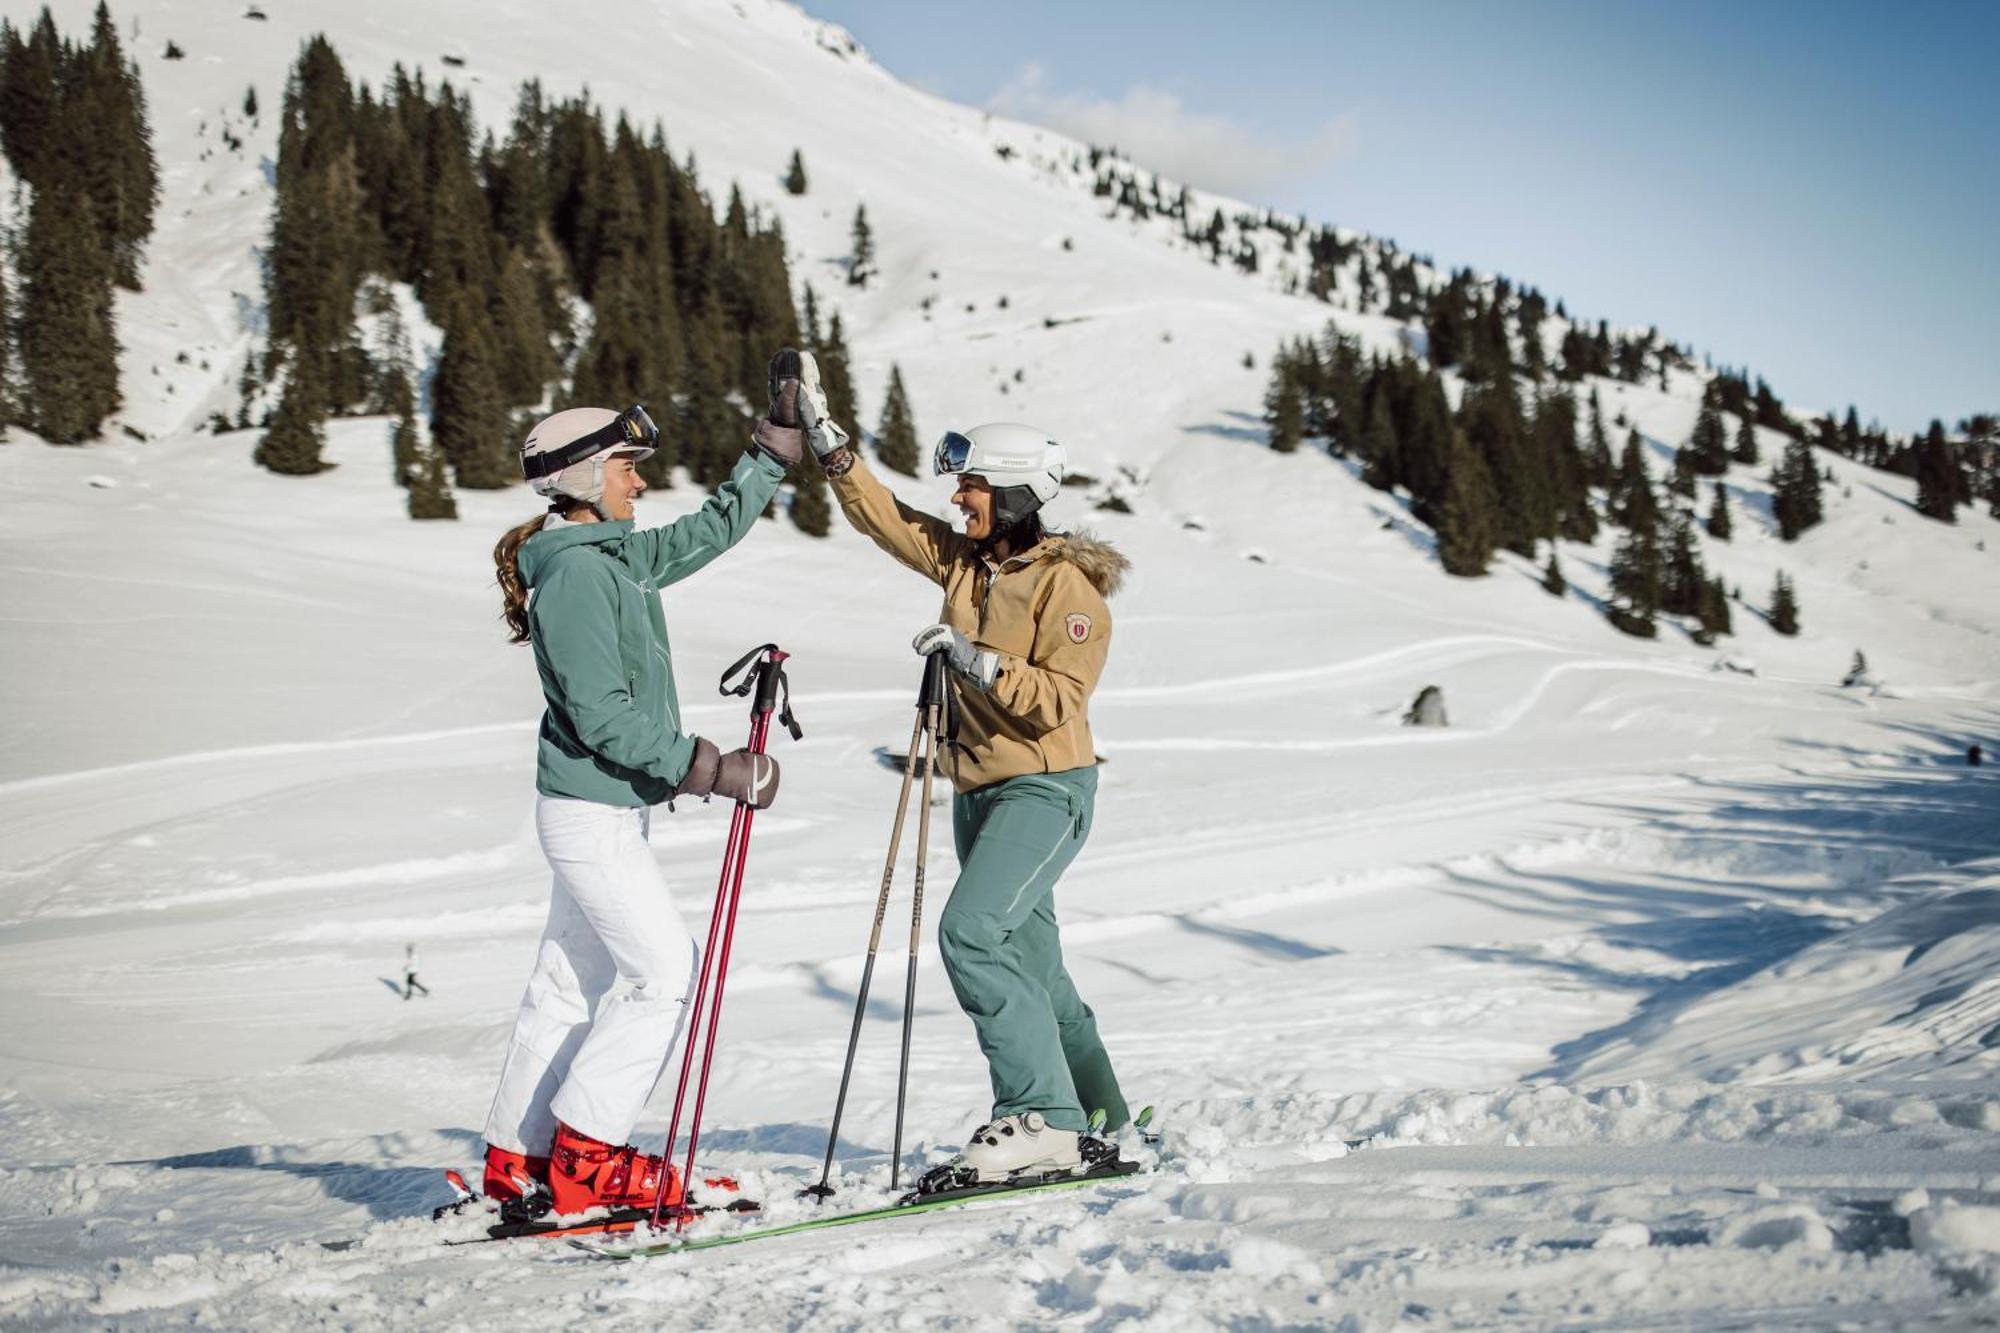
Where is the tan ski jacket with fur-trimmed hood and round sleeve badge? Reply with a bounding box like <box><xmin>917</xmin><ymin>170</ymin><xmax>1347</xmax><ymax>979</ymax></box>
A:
<box><xmin>826</xmin><ymin>450</ymin><xmax>1130</xmax><ymax>791</ymax></box>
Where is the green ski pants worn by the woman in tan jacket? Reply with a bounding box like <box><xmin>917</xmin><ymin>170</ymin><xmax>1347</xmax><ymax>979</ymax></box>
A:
<box><xmin>938</xmin><ymin>767</ymin><xmax>1132</xmax><ymax>1131</ymax></box>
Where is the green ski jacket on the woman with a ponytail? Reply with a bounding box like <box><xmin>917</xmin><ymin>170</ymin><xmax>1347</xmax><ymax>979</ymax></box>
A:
<box><xmin>520</xmin><ymin>452</ymin><xmax>784</xmax><ymax>807</ymax></box>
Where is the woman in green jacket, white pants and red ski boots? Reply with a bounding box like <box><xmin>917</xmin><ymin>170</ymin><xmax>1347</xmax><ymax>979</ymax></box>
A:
<box><xmin>484</xmin><ymin>408</ymin><xmax>800</xmax><ymax>1213</ymax></box>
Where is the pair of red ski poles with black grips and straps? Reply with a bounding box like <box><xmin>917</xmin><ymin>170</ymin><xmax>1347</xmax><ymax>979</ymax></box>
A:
<box><xmin>652</xmin><ymin>642</ymin><xmax>800</xmax><ymax>1227</ymax></box>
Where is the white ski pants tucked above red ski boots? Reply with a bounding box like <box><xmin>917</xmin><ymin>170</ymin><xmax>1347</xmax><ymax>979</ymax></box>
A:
<box><xmin>486</xmin><ymin>797</ymin><xmax>698</xmax><ymax>1157</ymax></box>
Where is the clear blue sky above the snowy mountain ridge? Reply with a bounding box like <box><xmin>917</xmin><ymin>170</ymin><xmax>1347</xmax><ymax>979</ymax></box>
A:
<box><xmin>806</xmin><ymin>0</ymin><xmax>2000</xmax><ymax>430</ymax></box>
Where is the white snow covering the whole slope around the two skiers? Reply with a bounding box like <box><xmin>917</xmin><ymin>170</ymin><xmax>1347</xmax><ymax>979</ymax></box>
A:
<box><xmin>0</xmin><ymin>0</ymin><xmax>2000</xmax><ymax>1329</ymax></box>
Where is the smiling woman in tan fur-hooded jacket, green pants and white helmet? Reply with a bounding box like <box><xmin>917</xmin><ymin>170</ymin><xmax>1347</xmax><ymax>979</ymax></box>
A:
<box><xmin>772</xmin><ymin>354</ymin><xmax>1132</xmax><ymax>1181</ymax></box>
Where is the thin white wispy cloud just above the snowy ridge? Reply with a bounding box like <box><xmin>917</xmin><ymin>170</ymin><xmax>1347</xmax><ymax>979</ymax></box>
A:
<box><xmin>986</xmin><ymin>64</ymin><xmax>1354</xmax><ymax>200</ymax></box>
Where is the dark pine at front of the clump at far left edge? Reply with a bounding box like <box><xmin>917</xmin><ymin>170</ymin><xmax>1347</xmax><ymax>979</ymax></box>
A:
<box><xmin>16</xmin><ymin>176</ymin><xmax>120</xmax><ymax>444</ymax></box>
